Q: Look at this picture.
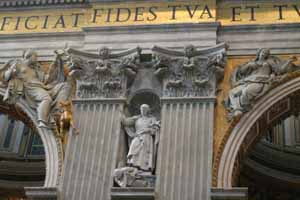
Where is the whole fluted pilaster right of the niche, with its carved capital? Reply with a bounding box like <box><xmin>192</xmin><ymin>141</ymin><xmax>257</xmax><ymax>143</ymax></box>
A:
<box><xmin>153</xmin><ymin>44</ymin><xmax>226</xmax><ymax>200</ymax></box>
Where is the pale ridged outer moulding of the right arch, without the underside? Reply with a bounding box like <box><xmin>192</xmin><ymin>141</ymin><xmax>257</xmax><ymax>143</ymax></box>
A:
<box><xmin>217</xmin><ymin>77</ymin><xmax>300</xmax><ymax>188</ymax></box>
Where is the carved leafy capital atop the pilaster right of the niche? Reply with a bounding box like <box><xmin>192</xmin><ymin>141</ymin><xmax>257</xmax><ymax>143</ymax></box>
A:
<box><xmin>152</xmin><ymin>44</ymin><xmax>226</xmax><ymax>97</ymax></box>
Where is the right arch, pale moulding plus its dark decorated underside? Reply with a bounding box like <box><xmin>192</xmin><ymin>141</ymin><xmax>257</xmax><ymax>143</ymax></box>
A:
<box><xmin>216</xmin><ymin>77</ymin><xmax>300</xmax><ymax>188</ymax></box>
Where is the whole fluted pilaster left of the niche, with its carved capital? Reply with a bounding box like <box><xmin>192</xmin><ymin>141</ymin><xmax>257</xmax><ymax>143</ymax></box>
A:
<box><xmin>61</xmin><ymin>48</ymin><xmax>139</xmax><ymax>200</ymax></box>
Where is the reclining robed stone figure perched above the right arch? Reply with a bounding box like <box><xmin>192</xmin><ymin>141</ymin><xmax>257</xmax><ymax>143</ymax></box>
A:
<box><xmin>224</xmin><ymin>49</ymin><xmax>299</xmax><ymax>119</ymax></box>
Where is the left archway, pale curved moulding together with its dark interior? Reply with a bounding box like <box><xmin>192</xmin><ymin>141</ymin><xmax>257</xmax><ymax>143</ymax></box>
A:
<box><xmin>0</xmin><ymin>89</ymin><xmax>62</xmax><ymax>196</ymax></box>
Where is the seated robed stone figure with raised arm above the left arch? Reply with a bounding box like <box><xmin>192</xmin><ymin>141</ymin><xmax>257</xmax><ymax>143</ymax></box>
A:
<box><xmin>0</xmin><ymin>50</ymin><xmax>72</xmax><ymax>128</ymax></box>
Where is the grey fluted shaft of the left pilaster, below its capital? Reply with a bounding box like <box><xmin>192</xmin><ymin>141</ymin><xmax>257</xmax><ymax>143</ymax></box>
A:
<box><xmin>62</xmin><ymin>100</ymin><xmax>123</xmax><ymax>200</ymax></box>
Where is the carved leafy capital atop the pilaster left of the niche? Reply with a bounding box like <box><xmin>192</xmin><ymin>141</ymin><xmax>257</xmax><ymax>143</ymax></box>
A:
<box><xmin>67</xmin><ymin>47</ymin><xmax>141</xmax><ymax>98</ymax></box>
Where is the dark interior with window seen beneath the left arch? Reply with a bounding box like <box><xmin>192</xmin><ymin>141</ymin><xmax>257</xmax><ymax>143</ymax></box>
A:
<box><xmin>0</xmin><ymin>111</ymin><xmax>46</xmax><ymax>200</ymax></box>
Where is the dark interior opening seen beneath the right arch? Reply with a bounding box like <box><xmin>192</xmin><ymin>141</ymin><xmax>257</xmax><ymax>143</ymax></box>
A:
<box><xmin>240</xmin><ymin>113</ymin><xmax>300</xmax><ymax>200</ymax></box>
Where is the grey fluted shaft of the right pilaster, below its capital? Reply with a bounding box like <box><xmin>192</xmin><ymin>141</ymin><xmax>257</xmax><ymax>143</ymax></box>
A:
<box><xmin>156</xmin><ymin>97</ymin><xmax>215</xmax><ymax>200</ymax></box>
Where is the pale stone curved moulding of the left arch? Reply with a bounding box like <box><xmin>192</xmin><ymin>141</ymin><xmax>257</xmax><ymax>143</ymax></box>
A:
<box><xmin>0</xmin><ymin>89</ymin><xmax>63</xmax><ymax>188</ymax></box>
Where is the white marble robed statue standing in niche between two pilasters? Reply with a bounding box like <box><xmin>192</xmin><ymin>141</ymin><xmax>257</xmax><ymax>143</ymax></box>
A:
<box><xmin>114</xmin><ymin>104</ymin><xmax>160</xmax><ymax>187</ymax></box>
